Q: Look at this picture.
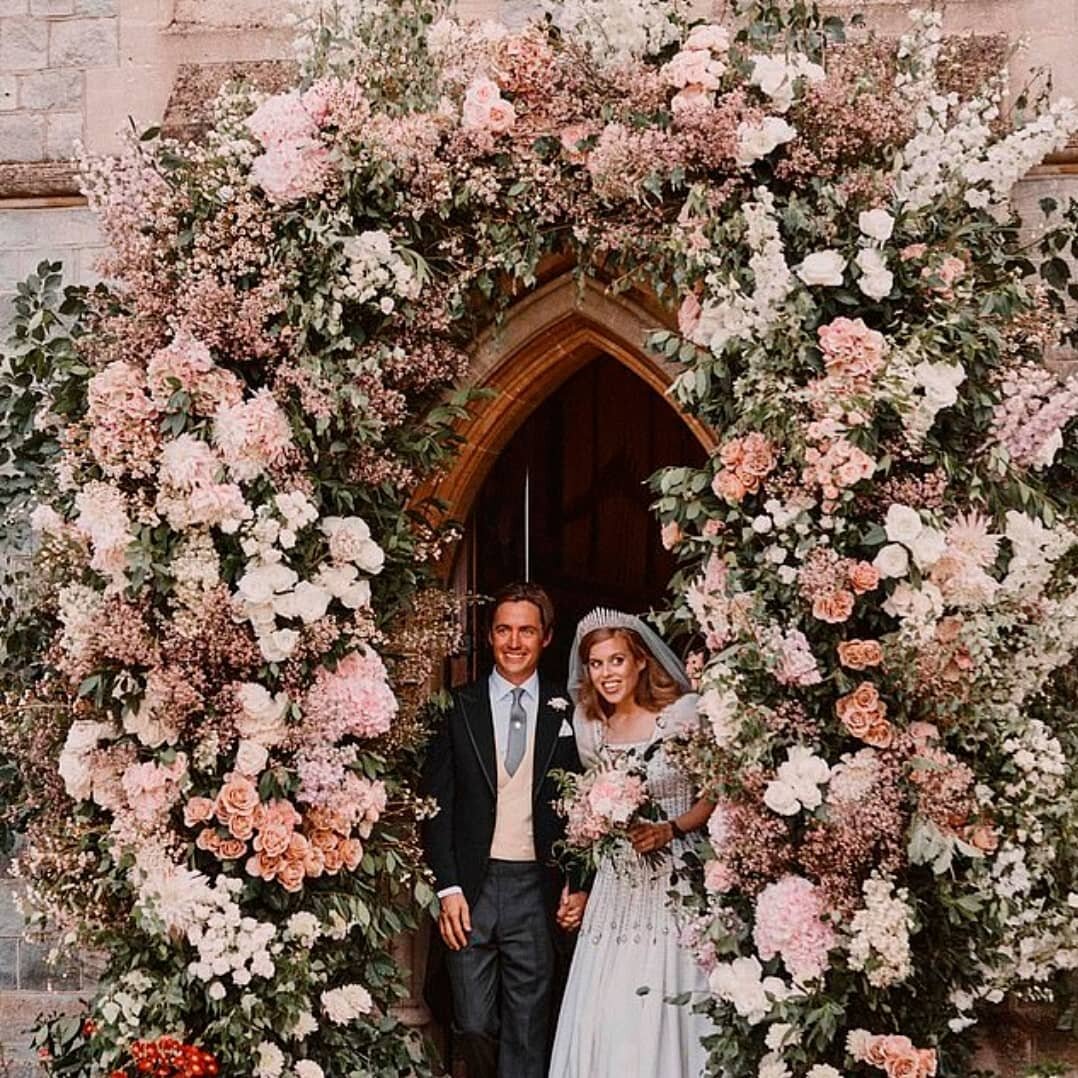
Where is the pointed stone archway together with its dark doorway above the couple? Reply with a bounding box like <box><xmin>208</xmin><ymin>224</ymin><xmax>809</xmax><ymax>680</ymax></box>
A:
<box><xmin>427</xmin><ymin>267</ymin><xmax>715</xmax><ymax>681</ymax></box>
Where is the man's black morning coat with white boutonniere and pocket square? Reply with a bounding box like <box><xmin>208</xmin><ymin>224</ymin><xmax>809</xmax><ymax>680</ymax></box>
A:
<box><xmin>423</xmin><ymin>677</ymin><xmax>581</xmax><ymax>906</ymax></box>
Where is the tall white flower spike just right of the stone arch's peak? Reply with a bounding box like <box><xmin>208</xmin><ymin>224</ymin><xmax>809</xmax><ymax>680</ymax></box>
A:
<box><xmin>688</xmin><ymin>188</ymin><xmax>793</xmax><ymax>353</ymax></box>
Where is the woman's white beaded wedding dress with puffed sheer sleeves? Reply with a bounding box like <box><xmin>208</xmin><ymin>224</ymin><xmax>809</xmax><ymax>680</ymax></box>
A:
<box><xmin>550</xmin><ymin>695</ymin><xmax>713</xmax><ymax>1078</ymax></box>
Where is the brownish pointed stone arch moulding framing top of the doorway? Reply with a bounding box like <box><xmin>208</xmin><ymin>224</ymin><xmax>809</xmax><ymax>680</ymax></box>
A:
<box><xmin>421</xmin><ymin>272</ymin><xmax>717</xmax><ymax>520</ymax></box>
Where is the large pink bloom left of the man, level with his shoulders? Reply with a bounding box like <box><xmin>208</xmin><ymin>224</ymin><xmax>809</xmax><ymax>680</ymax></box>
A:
<box><xmin>303</xmin><ymin>650</ymin><xmax>397</xmax><ymax>744</ymax></box>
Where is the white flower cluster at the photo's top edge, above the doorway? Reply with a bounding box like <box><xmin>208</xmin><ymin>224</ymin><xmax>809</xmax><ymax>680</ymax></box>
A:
<box><xmin>542</xmin><ymin>0</ymin><xmax>680</xmax><ymax>68</ymax></box>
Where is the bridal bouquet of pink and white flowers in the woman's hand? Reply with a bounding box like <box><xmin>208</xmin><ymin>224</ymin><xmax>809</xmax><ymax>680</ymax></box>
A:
<box><xmin>555</xmin><ymin>759</ymin><xmax>658</xmax><ymax>871</ymax></box>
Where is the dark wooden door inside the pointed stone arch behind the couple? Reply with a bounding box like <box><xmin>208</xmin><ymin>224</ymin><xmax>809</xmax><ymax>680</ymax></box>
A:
<box><xmin>454</xmin><ymin>356</ymin><xmax>705</xmax><ymax>680</ymax></box>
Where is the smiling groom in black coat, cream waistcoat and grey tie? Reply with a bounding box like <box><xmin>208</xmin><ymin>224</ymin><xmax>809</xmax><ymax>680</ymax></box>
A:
<box><xmin>423</xmin><ymin>583</ymin><xmax>586</xmax><ymax>1078</ymax></box>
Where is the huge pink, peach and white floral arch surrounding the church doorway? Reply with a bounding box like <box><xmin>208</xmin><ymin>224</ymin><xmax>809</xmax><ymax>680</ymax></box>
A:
<box><xmin>2</xmin><ymin>0</ymin><xmax>1078</xmax><ymax>1078</ymax></box>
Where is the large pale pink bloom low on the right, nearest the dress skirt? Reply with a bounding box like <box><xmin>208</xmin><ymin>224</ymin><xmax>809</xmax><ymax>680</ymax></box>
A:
<box><xmin>752</xmin><ymin>875</ymin><xmax>835</xmax><ymax>983</ymax></box>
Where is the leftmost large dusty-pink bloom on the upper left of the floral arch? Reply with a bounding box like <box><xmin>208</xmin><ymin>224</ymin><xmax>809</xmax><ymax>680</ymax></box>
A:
<box><xmin>86</xmin><ymin>362</ymin><xmax>158</xmax><ymax>476</ymax></box>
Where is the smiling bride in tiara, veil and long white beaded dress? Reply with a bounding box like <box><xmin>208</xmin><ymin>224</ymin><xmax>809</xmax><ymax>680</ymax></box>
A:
<box><xmin>550</xmin><ymin>609</ymin><xmax>713</xmax><ymax>1078</ymax></box>
